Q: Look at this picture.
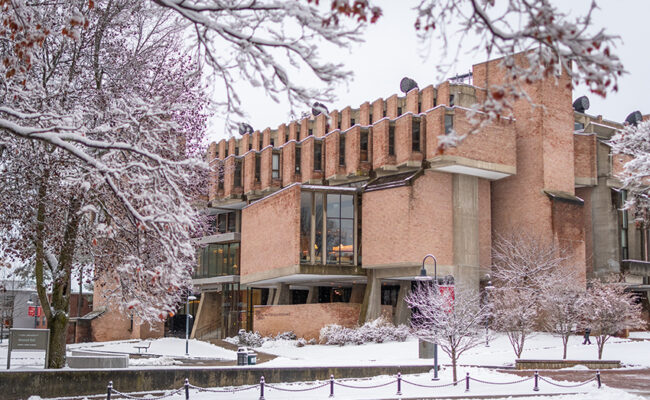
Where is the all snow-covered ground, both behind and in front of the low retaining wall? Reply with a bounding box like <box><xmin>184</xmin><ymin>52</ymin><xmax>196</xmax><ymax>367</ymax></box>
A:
<box><xmin>6</xmin><ymin>333</ymin><xmax>650</xmax><ymax>400</ymax></box>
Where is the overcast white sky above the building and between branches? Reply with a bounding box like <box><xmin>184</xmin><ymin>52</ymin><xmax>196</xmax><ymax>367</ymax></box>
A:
<box><xmin>208</xmin><ymin>0</ymin><xmax>650</xmax><ymax>141</ymax></box>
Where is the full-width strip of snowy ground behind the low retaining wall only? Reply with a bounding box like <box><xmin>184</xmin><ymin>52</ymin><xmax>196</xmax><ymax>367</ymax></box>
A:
<box><xmin>0</xmin><ymin>332</ymin><xmax>650</xmax><ymax>370</ymax></box>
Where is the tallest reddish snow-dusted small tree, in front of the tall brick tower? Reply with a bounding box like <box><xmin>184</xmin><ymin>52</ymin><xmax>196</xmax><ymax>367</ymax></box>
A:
<box><xmin>490</xmin><ymin>232</ymin><xmax>573</xmax><ymax>358</ymax></box>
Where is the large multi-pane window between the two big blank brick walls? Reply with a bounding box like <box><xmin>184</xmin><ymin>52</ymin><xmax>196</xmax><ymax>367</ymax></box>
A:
<box><xmin>300</xmin><ymin>191</ymin><xmax>355</xmax><ymax>265</ymax></box>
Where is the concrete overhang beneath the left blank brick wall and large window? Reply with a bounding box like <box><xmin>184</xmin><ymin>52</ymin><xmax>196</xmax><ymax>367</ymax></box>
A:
<box><xmin>241</xmin><ymin>264</ymin><xmax>366</xmax><ymax>287</ymax></box>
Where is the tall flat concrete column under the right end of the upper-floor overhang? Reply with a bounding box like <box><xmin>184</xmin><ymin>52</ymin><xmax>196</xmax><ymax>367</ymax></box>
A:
<box><xmin>452</xmin><ymin>174</ymin><xmax>479</xmax><ymax>290</ymax></box>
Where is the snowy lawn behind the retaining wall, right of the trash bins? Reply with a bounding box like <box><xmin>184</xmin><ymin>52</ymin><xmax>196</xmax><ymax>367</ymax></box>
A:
<box><xmin>251</xmin><ymin>333</ymin><xmax>650</xmax><ymax>367</ymax></box>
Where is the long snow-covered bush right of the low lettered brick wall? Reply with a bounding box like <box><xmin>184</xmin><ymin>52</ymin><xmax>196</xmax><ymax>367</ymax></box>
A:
<box><xmin>320</xmin><ymin>317</ymin><xmax>409</xmax><ymax>346</ymax></box>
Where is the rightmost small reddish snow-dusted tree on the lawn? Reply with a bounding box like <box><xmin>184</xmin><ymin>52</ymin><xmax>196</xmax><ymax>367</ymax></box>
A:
<box><xmin>580</xmin><ymin>280</ymin><xmax>646</xmax><ymax>360</ymax></box>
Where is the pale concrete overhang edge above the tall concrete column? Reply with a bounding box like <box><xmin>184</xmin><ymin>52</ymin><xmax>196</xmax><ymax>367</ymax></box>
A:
<box><xmin>427</xmin><ymin>155</ymin><xmax>517</xmax><ymax>180</ymax></box>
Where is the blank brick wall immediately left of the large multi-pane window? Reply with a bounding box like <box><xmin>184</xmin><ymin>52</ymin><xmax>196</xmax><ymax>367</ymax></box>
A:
<box><xmin>241</xmin><ymin>185</ymin><xmax>300</xmax><ymax>279</ymax></box>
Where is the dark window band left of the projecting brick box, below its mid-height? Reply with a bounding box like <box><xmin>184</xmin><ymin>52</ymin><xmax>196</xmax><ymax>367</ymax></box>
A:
<box><xmin>194</xmin><ymin>243</ymin><xmax>239</xmax><ymax>279</ymax></box>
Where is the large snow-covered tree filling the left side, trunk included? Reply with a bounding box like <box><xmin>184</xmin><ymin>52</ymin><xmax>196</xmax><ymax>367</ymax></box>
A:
<box><xmin>0</xmin><ymin>0</ymin><xmax>205</xmax><ymax>368</ymax></box>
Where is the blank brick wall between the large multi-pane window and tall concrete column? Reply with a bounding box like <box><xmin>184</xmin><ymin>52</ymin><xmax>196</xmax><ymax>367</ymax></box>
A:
<box><xmin>362</xmin><ymin>171</ymin><xmax>453</xmax><ymax>267</ymax></box>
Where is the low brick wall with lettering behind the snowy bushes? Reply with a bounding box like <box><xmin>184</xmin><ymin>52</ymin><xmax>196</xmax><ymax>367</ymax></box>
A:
<box><xmin>253</xmin><ymin>303</ymin><xmax>392</xmax><ymax>340</ymax></box>
